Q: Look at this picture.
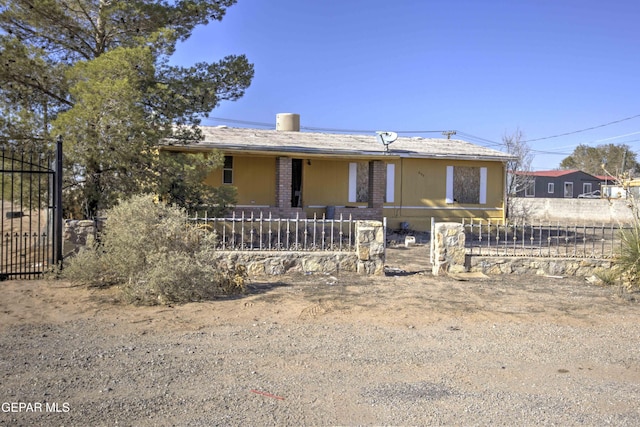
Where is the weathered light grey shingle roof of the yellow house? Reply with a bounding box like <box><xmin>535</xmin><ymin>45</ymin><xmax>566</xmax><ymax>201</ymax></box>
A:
<box><xmin>168</xmin><ymin>126</ymin><xmax>513</xmax><ymax>161</ymax></box>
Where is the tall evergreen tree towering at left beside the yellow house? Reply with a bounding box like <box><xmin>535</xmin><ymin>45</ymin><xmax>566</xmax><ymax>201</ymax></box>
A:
<box><xmin>0</xmin><ymin>0</ymin><xmax>253</xmax><ymax>217</ymax></box>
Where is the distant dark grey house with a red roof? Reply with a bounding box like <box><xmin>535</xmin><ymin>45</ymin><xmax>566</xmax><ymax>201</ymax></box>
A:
<box><xmin>516</xmin><ymin>170</ymin><xmax>602</xmax><ymax>199</ymax></box>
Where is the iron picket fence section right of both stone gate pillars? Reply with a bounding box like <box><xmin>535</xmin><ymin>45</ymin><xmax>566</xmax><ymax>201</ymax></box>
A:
<box><xmin>463</xmin><ymin>220</ymin><xmax>631</xmax><ymax>258</ymax></box>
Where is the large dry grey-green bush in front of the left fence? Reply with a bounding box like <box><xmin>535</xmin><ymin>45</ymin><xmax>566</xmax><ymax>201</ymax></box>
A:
<box><xmin>63</xmin><ymin>195</ymin><xmax>246</xmax><ymax>304</ymax></box>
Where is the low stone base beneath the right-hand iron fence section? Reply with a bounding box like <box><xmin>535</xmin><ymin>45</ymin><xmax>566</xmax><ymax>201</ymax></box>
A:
<box><xmin>466</xmin><ymin>256</ymin><xmax>613</xmax><ymax>277</ymax></box>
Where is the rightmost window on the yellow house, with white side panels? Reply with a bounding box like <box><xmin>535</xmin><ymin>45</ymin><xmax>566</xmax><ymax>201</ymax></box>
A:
<box><xmin>446</xmin><ymin>166</ymin><xmax>487</xmax><ymax>204</ymax></box>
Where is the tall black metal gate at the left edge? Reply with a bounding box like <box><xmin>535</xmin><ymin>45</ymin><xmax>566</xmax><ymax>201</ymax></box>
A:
<box><xmin>0</xmin><ymin>139</ymin><xmax>62</xmax><ymax>280</ymax></box>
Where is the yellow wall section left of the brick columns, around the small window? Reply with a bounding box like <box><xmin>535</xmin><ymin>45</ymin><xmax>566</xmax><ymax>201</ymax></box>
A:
<box><xmin>204</xmin><ymin>155</ymin><xmax>276</xmax><ymax>206</ymax></box>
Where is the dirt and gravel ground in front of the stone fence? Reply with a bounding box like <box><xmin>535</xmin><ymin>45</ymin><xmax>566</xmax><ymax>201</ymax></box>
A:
<box><xmin>0</xmin><ymin>245</ymin><xmax>640</xmax><ymax>425</ymax></box>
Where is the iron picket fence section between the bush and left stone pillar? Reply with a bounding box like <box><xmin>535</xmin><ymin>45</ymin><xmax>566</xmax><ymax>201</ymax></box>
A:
<box><xmin>188</xmin><ymin>213</ymin><xmax>356</xmax><ymax>251</ymax></box>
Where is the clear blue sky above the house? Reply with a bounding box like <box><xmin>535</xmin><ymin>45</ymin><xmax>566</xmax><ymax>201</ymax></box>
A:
<box><xmin>172</xmin><ymin>0</ymin><xmax>640</xmax><ymax>170</ymax></box>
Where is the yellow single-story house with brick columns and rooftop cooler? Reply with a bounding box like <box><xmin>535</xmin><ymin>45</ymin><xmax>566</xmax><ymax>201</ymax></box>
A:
<box><xmin>163</xmin><ymin>114</ymin><xmax>513</xmax><ymax>230</ymax></box>
